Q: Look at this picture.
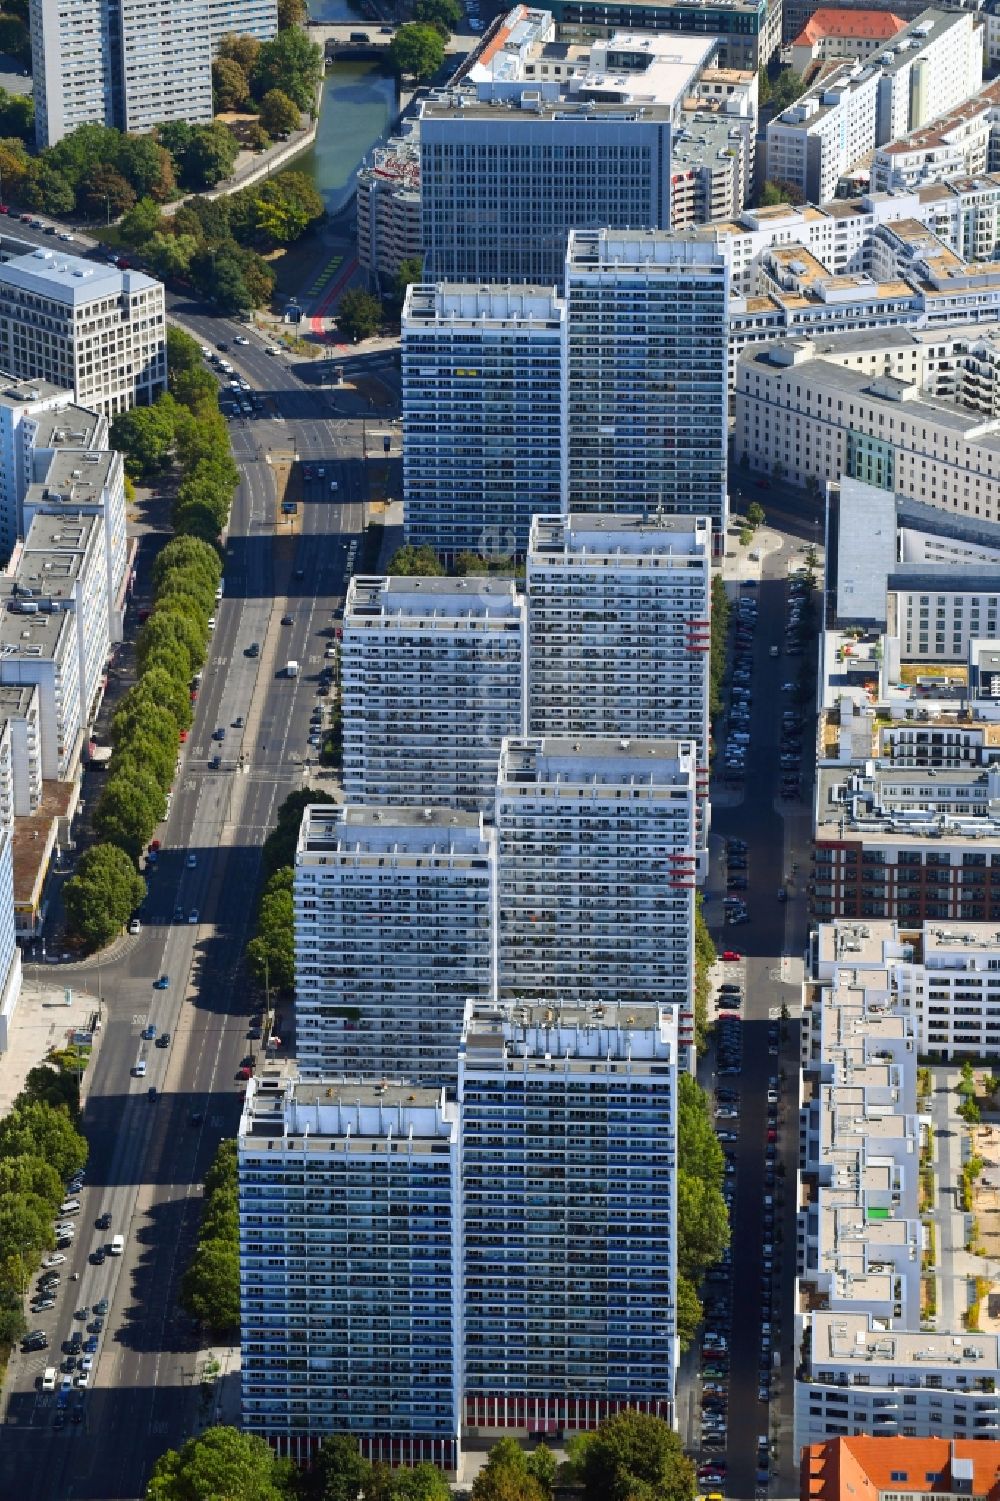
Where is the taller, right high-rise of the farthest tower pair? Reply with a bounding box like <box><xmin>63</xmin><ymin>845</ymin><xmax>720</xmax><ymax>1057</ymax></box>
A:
<box><xmin>564</xmin><ymin>230</ymin><xmax>728</xmax><ymax>536</ymax></box>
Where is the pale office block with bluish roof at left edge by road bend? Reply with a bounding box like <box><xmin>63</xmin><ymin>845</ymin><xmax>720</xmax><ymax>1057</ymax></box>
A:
<box><xmin>0</xmin><ymin>249</ymin><xmax>167</xmax><ymax>417</ymax></box>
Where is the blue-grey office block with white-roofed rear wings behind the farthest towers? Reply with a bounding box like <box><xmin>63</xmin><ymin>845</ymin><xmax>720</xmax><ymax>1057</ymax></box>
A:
<box><xmin>420</xmin><ymin>6</ymin><xmax>718</xmax><ymax>285</ymax></box>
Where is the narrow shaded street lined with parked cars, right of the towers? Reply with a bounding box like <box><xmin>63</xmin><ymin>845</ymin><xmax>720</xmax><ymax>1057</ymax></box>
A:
<box><xmin>680</xmin><ymin>531</ymin><xmax>812</xmax><ymax>1496</ymax></box>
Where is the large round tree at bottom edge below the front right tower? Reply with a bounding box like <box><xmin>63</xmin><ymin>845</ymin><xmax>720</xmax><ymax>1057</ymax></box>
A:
<box><xmin>567</xmin><ymin>1408</ymin><xmax>695</xmax><ymax>1501</ymax></box>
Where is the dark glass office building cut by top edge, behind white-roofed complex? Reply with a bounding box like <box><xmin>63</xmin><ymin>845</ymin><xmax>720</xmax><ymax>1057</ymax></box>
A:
<box><xmin>550</xmin><ymin>0</ymin><xmax>780</xmax><ymax>74</ymax></box>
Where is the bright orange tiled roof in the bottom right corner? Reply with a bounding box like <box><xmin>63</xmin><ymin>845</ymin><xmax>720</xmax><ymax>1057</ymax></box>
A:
<box><xmin>799</xmin><ymin>1433</ymin><xmax>1000</xmax><ymax>1501</ymax></box>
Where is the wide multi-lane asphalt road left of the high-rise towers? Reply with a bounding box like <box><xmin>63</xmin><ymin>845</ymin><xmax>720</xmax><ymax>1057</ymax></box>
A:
<box><xmin>0</xmin><ymin>298</ymin><xmax>363</xmax><ymax>1501</ymax></box>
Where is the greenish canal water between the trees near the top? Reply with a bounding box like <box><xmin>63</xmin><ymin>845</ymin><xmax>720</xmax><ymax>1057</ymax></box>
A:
<box><xmin>294</xmin><ymin>0</ymin><xmax>398</xmax><ymax>215</ymax></box>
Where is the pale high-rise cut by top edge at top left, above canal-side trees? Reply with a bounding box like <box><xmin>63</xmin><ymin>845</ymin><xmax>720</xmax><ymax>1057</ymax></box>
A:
<box><xmin>29</xmin><ymin>0</ymin><xmax>278</xmax><ymax>150</ymax></box>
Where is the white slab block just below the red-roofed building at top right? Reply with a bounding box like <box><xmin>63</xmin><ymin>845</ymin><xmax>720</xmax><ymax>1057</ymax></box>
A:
<box><xmin>767</xmin><ymin>63</ymin><xmax>878</xmax><ymax>203</ymax></box>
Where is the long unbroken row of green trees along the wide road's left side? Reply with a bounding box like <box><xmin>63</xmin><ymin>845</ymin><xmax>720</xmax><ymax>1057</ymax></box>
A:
<box><xmin>65</xmin><ymin>329</ymin><xmax>231</xmax><ymax>949</ymax></box>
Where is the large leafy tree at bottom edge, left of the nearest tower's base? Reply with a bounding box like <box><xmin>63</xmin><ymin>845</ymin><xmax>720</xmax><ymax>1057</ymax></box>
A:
<box><xmin>146</xmin><ymin>1427</ymin><xmax>294</xmax><ymax>1501</ymax></box>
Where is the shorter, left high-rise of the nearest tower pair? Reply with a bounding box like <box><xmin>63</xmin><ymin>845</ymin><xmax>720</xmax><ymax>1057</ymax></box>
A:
<box><xmin>237</xmin><ymin>1067</ymin><xmax>461</xmax><ymax>1471</ymax></box>
